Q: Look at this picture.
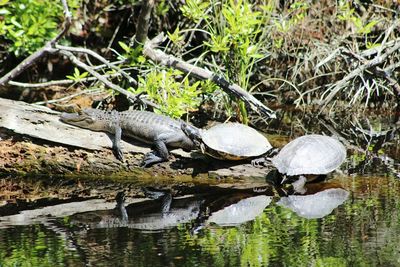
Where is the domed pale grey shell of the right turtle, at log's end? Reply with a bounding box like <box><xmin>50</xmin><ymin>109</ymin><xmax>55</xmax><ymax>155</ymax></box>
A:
<box><xmin>271</xmin><ymin>134</ymin><xmax>346</xmax><ymax>176</ymax></box>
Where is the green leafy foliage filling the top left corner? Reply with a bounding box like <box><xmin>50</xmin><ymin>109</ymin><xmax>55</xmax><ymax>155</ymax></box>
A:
<box><xmin>0</xmin><ymin>0</ymin><xmax>63</xmax><ymax>57</ymax></box>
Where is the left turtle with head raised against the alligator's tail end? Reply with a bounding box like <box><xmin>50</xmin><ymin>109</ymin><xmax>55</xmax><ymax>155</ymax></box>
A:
<box><xmin>181</xmin><ymin>122</ymin><xmax>272</xmax><ymax>160</ymax></box>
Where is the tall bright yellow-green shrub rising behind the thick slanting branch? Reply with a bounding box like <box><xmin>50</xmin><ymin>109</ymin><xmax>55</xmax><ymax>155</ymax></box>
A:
<box><xmin>181</xmin><ymin>0</ymin><xmax>264</xmax><ymax>122</ymax></box>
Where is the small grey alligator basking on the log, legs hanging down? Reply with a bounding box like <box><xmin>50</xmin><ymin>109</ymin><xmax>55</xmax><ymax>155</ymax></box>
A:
<box><xmin>60</xmin><ymin>108</ymin><xmax>195</xmax><ymax>167</ymax></box>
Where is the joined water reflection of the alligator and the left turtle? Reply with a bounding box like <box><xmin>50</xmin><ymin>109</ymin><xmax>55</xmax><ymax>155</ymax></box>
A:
<box><xmin>70</xmin><ymin>190</ymin><xmax>272</xmax><ymax>231</ymax></box>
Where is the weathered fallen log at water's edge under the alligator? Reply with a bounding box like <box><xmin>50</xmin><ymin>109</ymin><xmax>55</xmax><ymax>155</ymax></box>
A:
<box><xmin>0</xmin><ymin>98</ymin><xmax>267</xmax><ymax>180</ymax></box>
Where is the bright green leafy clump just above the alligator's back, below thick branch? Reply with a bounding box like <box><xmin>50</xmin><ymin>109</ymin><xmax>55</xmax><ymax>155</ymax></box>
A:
<box><xmin>130</xmin><ymin>70</ymin><xmax>206</xmax><ymax>118</ymax></box>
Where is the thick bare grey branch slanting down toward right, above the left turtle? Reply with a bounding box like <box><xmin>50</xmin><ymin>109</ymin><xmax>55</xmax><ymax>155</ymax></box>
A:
<box><xmin>143</xmin><ymin>34</ymin><xmax>275</xmax><ymax>118</ymax></box>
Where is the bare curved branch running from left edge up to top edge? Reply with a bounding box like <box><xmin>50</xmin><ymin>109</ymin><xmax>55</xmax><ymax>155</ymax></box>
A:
<box><xmin>0</xmin><ymin>0</ymin><xmax>71</xmax><ymax>87</ymax></box>
